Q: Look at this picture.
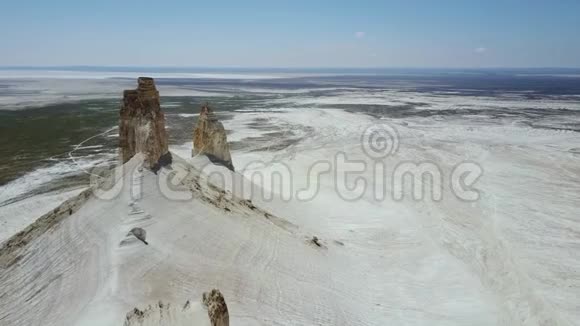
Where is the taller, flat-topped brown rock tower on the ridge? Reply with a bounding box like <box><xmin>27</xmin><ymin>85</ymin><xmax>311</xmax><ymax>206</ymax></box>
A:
<box><xmin>119</xmin><ymin>77</ymin><xmax>168</xmax><ymax>167</ymax></box>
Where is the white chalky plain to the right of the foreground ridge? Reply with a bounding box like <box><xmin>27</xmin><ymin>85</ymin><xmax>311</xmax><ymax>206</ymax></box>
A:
<box><xmin>218</xmin><ymin>108</ymin><xmax>580</xmax><ymax>325</ymax></box>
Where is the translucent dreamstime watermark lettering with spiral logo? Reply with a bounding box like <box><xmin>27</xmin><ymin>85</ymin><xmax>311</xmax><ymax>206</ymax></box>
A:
<box><xmin>90</xmin><ymin>123</ymin><xmax>484</xmax><ymax>202</ymax></box>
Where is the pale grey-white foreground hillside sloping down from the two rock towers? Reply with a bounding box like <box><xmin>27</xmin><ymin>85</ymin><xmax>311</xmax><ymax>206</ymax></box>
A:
<box><xmin>0</xmin><ymin>152</ymin><xmax>408</xmax><ymax>325</ymax></box>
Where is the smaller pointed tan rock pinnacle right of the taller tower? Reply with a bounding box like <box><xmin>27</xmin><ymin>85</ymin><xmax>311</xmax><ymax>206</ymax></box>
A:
<box><xmin>192</xmin><ymin>104</ymin><xmax>234</xmax><ymax>171</ymax></box>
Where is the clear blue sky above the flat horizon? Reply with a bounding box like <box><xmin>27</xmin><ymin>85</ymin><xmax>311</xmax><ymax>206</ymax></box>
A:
<box><xmin>0</xmin><ymin>0</ymin><xmax>580</xmax><ymax>67</ymax></box>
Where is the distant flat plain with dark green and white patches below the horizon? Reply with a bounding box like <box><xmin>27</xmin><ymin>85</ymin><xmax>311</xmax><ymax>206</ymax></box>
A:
<box><xmin>0</xmin><ymin>67</ymin><xmax>580</xmax><ymax>203</ymax></box>
